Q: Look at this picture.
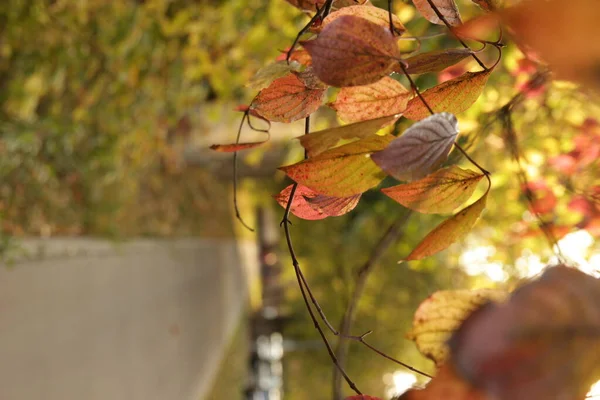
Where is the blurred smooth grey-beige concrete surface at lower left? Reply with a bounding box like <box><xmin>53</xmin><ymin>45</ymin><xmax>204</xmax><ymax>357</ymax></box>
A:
<box><xmin>0</xmin><ymin>239</ymin><xmax>256</xmax><ymax>400</ymax></box>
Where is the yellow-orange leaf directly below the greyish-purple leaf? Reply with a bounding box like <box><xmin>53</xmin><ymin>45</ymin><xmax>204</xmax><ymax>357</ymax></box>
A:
<box><xmin>381</xmin><ymin>166</ymin><xmax>484</xmax><ymax>214</ymax></box>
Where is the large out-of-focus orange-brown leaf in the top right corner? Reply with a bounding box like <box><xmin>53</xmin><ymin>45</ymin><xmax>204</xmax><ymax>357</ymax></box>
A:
<box><xmin>501</xmin><ymin>0</ymin><xmax>600</xmax><ymax>90</ymax></box>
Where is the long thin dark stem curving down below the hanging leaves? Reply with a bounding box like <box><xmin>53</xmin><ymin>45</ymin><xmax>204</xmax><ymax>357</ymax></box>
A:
<box><xmin>281</xmin><ymin>117</ymin><xmax>362</xmax><ymax>394</ymax></box>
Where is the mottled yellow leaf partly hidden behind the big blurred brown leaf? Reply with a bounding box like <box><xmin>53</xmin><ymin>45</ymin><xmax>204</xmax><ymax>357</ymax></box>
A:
<box><xmin>406</xmin><ymin>289</ymin><xmax>507</xmax><ymax>366</ymax></box>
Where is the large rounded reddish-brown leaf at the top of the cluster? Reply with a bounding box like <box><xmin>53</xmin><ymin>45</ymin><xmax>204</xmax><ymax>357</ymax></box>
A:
<box><xmin>301</xmin><ymin>15</ymin><xmax>400</xmax><ymax>87</ymax></box>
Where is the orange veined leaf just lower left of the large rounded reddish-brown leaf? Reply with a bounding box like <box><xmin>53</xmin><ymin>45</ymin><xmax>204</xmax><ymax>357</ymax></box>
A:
<box><xmin>250</xmin><ymin>72</ymin><xmax>325</xmax><ymax>122</ymax></box>
